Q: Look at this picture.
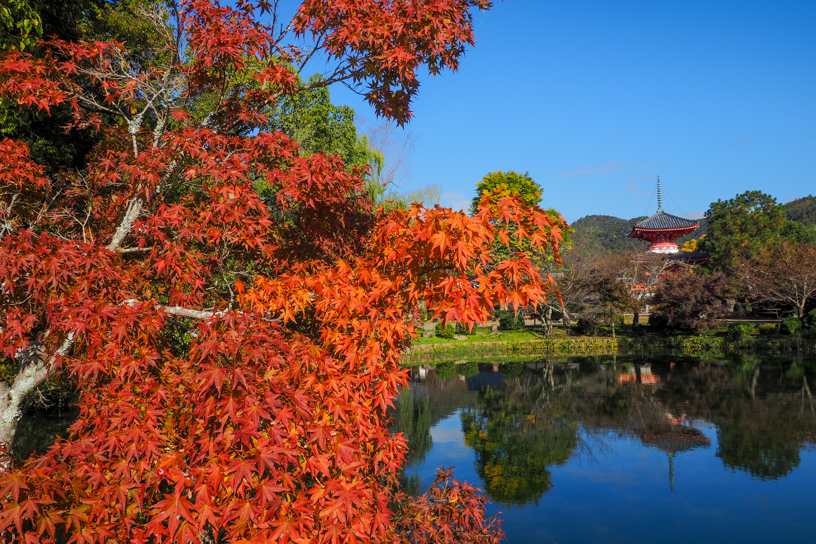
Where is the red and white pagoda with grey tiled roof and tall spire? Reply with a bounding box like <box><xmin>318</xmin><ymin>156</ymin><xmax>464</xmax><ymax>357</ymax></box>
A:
<box><xmin>629</xmin><ymin>177</ymin><xmax>711</xmax><ymax>268</ymax></box>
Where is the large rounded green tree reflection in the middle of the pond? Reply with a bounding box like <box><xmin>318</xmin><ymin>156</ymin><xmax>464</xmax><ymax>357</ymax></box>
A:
<box><xmin>461</xmin><ymin>379</ymin><xmax>578</xmax><ymax>505</ymax></box>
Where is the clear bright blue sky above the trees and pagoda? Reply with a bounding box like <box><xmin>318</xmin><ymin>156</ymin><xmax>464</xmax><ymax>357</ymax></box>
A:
<box><xmin>315</xmin><ymin>0</ymin><xmax>816</xmax><ymax>221</ymax></box>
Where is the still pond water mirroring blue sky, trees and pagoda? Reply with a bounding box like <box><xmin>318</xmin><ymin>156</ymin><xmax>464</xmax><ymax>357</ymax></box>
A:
<box><xmin>394</xmin><ymin>357</ymin><xmax>816</xmax><ymax>544</ymax></box>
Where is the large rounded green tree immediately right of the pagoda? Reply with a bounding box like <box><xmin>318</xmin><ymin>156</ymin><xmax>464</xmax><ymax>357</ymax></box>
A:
<box><xmin>698</xmin><ymin>191</ymin><xmax>785</xmax><ymax>272</ymax></box>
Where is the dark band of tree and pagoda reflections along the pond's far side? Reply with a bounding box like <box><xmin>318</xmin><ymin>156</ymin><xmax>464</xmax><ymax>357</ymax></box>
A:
<box><xmin>395</xmin><ymin>357</ymin><xmax>816</xmax><ymax>507</ymax></box>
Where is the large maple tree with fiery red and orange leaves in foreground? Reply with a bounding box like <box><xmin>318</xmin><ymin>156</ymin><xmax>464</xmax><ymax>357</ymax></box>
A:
<box><xmin>0</xmin><ymin>0</ymin><xmax>565</xmax><ymax>543</ymax></box>
